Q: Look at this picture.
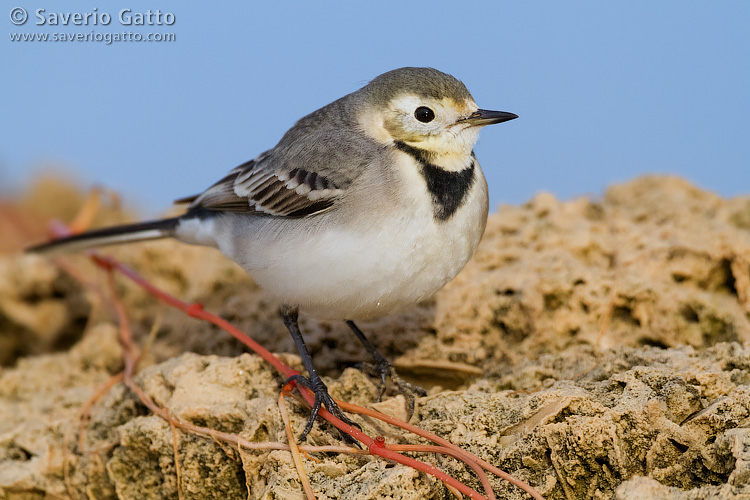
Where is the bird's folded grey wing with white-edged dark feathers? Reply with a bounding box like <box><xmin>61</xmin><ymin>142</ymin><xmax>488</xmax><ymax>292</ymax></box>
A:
<box><xmin>179</xmin><ymin>131</ymin><xmax>378</xmax><ymax>217</ymax></box>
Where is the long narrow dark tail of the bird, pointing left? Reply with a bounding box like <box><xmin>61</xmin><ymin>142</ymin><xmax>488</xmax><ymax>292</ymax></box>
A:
<box><xmin>26</xmin><ymin>217</ymin><xmax>179</xmax><ymax>255</ymax></box>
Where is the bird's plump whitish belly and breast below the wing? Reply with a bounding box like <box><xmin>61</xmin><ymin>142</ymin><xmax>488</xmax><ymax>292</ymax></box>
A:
<box><xmin>179</xmin><ymin>162</ymin><xmax>487</xmax><ymax>320</ymax></box>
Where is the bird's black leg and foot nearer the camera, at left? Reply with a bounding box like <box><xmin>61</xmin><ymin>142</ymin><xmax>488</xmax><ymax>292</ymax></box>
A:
<box><xmin>280</xmin><ymin>306</ymin><xmax>359</xmax><ymax>445</ymax></box>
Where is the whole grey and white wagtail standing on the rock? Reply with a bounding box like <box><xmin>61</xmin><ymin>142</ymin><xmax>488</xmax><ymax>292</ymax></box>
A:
<box><xmin>31</xmin><ymin>68</ymin><xmax>517</xmax><ymax>439</ymax></box>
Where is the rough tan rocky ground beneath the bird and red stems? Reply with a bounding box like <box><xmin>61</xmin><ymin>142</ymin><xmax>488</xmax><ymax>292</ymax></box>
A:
<box><xmin>0</xmin><ymin>177</ymin><xmax>750</xmax><ymax>500</ymax></box>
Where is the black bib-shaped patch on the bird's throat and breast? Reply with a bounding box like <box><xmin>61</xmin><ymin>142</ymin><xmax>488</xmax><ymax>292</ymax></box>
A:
<box><xmin>395</xmin><ymin>141</ymin><xmax>475</xmax><ymax>221</ymax></box>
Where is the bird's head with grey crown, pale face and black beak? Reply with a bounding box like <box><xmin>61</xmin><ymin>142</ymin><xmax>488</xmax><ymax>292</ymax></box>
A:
<box><xmin>357</xmin><ymin>68</ymin><xmax>517</xmax><ymax>169</ymax></box>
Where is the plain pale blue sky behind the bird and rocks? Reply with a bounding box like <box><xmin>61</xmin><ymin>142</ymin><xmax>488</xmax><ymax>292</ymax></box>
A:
<box><xmin>0</xmin><ymin>0</ymin><xmax>750</xmax><ymax>215</ymax></box>
